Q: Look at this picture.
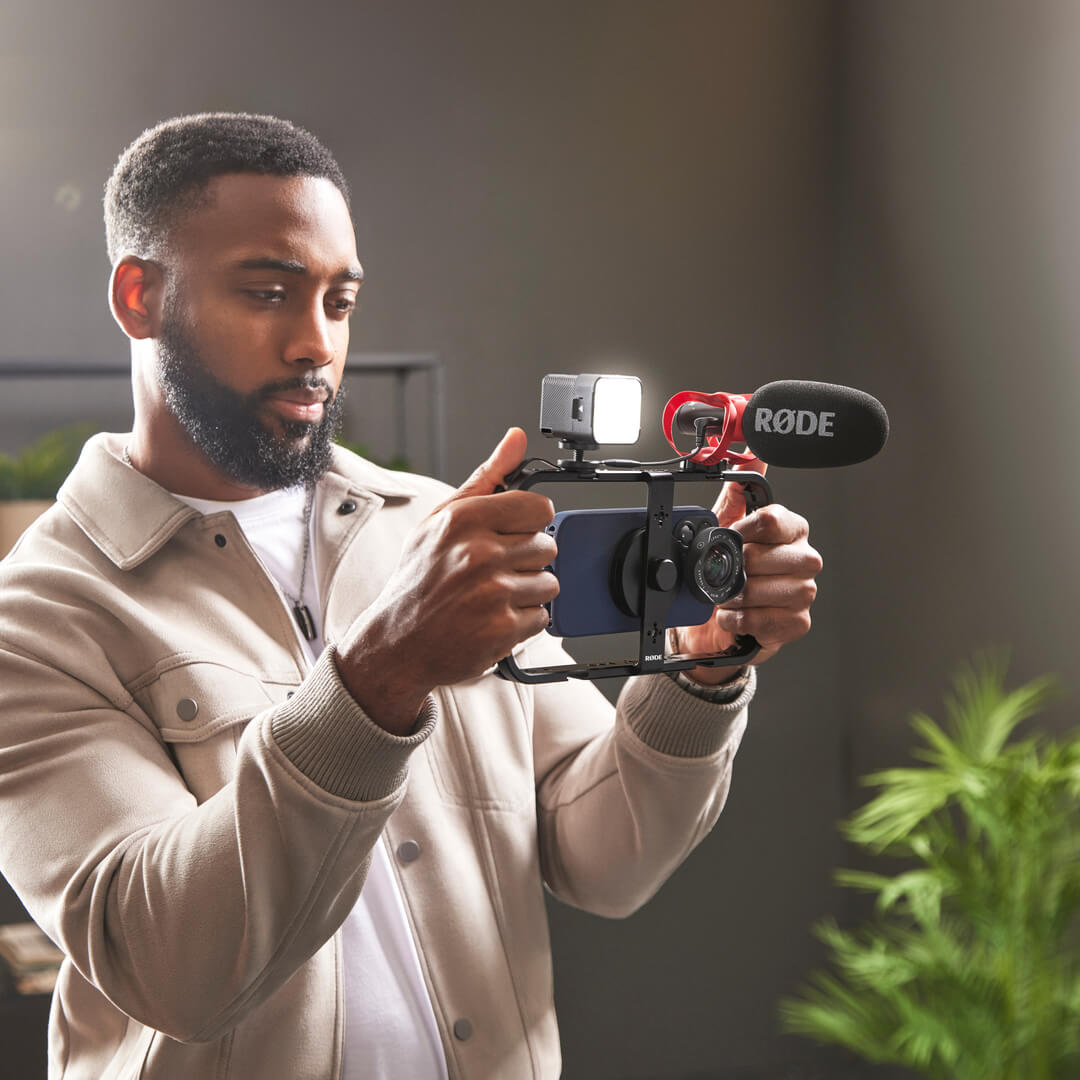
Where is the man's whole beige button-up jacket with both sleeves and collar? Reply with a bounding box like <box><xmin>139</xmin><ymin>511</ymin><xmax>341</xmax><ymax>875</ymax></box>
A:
<box><xmin>0</xmin><ymin>435</ymin><xmax>753</xmax><ymax>1080</ymax></box>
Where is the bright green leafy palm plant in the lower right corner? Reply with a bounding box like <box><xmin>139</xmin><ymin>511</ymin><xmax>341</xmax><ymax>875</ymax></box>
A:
<box><xmin>781</xmin><ymin>660</ymin><xmax>1080</xmax><ymax>1080</ymax></box>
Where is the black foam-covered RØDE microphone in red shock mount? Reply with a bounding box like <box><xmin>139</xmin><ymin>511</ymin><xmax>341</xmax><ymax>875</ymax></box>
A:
<box><xmin>664</xmin><ymin>379</ymin><xmax>889</xmax><ymax>469</ymax></box>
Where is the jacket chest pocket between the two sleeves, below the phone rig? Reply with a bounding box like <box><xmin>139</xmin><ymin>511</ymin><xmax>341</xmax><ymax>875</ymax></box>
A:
<box><xmin>424</xmin><ymin>675</ymin><xmax>536</xmax><ymax>810</ymax></box>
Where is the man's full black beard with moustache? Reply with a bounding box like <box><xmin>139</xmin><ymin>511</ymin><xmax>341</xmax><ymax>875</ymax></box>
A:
<box><xmin>158</xmin><ymin>314</ymin><xmax>345</xmax><ymax>491</ymax></box>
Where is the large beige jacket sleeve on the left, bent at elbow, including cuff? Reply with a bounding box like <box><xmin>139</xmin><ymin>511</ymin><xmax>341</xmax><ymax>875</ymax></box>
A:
<box><xmin>0</xmin><ymin>646</ymin><xmax>434</xmax><ymax>1041</ymax></box>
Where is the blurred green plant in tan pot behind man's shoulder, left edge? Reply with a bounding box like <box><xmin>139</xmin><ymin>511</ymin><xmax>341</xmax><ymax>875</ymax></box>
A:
<box><xmin>0</xmin><ymin>423</ymin><xmax>96</xmax><ymax>558</ymax></box>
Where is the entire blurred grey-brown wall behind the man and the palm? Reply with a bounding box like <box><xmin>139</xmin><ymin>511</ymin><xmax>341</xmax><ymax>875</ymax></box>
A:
<box><xmin>0</xmin><ymin>0</ymin><xmax>1080</xmax><ymax>1080</ymax></box>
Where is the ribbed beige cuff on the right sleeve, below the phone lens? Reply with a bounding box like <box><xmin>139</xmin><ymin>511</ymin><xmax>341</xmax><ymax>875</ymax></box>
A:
<box><xmin>619</xmin><ymin>667</ymin><xmax>757</xmax><ymax>757</ymax></box>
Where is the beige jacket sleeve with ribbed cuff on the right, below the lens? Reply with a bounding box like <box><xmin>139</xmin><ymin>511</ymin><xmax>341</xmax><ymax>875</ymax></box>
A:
<box><xmin>522</xmin><ymin>635</ymin><xmax>756</xmax><ymax>917</ymax></box>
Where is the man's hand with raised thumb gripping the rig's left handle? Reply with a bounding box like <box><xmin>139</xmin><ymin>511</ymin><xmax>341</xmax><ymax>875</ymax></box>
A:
<box><xmin>338</xmin><ymin>428</ymin><xmax>558</xmax><ymax>734</ymax></box>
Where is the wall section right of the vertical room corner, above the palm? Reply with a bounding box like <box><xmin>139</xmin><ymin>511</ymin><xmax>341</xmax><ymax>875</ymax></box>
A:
<box><xmin>834</xmin><ymin>0</ymin><xmax>1080</xmax><ymax>773</ymax></box>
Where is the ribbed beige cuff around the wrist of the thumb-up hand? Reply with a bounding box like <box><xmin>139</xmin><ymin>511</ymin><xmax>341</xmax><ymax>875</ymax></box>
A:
<box><xmin>270</xmin><ymin>646</ymin><xmax>436</xmax><ymax>802</ymax></box>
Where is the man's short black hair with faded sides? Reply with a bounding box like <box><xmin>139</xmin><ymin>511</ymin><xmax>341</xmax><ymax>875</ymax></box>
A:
<box><xmin>105</xmin><ymin>112</ymin><xmax>349</xmax><ymax>264</ymax></box>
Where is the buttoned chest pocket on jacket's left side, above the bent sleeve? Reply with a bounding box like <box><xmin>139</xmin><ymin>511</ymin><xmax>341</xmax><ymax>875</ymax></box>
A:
<box><xmin>133</xmin><ymin>661</ymin><xmax>291</xmax><ymax>802</ymax></box>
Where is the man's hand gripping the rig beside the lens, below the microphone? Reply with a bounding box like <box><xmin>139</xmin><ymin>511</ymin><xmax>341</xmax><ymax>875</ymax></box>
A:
<box><xmin>677</xmin><ymin>462</ymin><xmax>822</xmax><ymax>685</ymax></box>
